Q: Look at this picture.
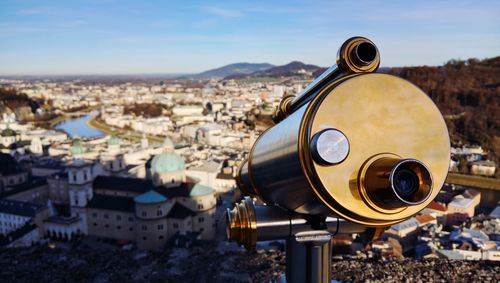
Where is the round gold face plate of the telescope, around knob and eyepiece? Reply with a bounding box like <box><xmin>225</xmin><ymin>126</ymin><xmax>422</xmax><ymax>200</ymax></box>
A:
<box><xmin>299</xmin><ymin>74</ymin><xmax>450</xmax><ymax>226</ymax></box>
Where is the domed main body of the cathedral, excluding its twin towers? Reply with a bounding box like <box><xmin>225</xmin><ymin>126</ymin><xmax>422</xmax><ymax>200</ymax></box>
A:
<box><xmin>86</xmin><ymin>140</ymin><xmax>216</xmax><ymax>250</ymax></box>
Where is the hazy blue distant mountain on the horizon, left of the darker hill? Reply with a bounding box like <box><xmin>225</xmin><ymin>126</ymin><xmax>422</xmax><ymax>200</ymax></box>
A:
<box><xmin>187</xmin><ymin>63</ymin><xmax>274</xmax><ymax>79</ymax></box>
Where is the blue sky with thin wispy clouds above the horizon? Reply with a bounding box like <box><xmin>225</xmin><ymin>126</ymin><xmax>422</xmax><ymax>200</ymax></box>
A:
<box><xmin>0</xmin><ymin>0</ymin><xmax>500</xmax><ymax>75</ymax></box>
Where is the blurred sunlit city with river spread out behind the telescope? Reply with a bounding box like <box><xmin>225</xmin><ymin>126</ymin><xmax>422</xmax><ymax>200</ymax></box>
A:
<box><xmin>0</xmin><ymin>57</ymin><xmax>500</xmax><ymax>268</ymax></box>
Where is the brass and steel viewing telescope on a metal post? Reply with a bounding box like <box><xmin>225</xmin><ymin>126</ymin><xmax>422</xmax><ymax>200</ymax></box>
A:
<box><xmin>227</xmin><ymin>37</ymin><xmax>450</xmax><ymax>282</ymax></box>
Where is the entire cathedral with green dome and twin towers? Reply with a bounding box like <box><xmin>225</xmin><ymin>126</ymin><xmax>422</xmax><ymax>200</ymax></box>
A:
<box><xmin>44</xmin><ymin>136</ymin><xmax>216</xmax><ymax>250</ymax></box>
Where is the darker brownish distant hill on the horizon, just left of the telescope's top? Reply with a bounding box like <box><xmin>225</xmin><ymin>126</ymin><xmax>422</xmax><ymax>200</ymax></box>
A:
<box><xmin>225</xmin><ymin>61</ymin><xmax>322</xmax><ymax>79</ymax></box>
